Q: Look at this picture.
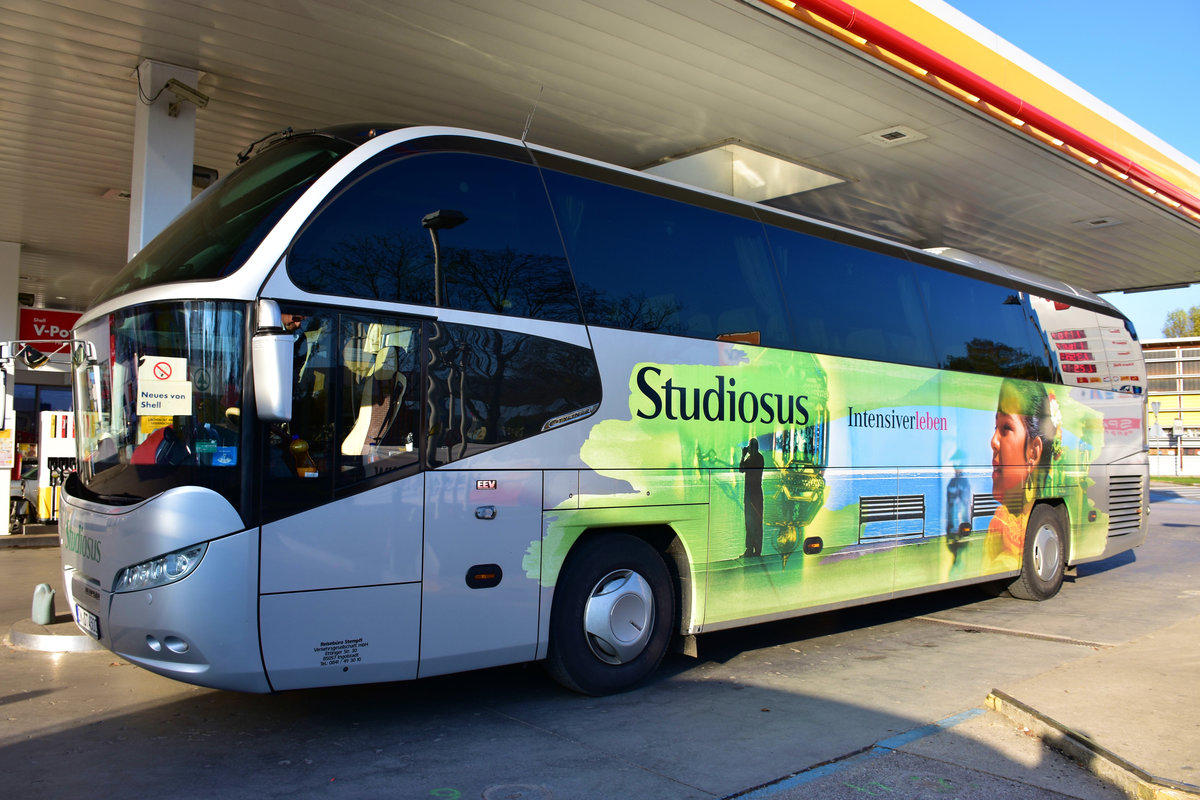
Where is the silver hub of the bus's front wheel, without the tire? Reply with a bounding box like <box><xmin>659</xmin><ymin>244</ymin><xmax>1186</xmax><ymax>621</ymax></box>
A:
<box><xmin>583</xmin><ymin>570</ymin><xmax>654</xmax><ymax>664</ymax></box>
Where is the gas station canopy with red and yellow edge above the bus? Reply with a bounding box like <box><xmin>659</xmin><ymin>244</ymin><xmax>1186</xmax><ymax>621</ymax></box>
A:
<box><xmin>0</xmin><ymin>0</ymin><xmax>1200</xmax><ymax>309</ymax></box>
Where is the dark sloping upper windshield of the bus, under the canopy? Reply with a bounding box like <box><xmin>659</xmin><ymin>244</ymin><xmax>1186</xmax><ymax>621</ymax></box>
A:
<box><xmin>96</xmin><ymin>136</ymin><xmax>354</xmax><ymax>302</ymax></box>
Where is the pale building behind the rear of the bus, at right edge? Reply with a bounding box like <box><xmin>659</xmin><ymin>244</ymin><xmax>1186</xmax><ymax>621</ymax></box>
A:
<box><xmin>1141</xmin><ymin>337</ymin><xmax>1200</xmax><ymax>475</ymax></box>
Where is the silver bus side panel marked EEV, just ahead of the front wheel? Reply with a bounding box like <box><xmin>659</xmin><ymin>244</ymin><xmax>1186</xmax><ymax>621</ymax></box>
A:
<box><xmin>419</xmin><ymin>470</ymin><xmax>542</xmax><ymax>678</ymax></box>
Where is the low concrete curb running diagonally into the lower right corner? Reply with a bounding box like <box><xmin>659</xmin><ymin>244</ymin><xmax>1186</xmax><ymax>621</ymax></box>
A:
<box><xmin>985</xmin><ymin>688</ymin><xmax>1200</xmax><ymax>800</ymax></box>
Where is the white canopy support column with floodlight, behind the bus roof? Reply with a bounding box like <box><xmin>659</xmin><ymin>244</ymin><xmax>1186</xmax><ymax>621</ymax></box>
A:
<box><xmin>128</xmin><ymin>60</ymin><xmax>199</xmax><ymax>258</ymax></box>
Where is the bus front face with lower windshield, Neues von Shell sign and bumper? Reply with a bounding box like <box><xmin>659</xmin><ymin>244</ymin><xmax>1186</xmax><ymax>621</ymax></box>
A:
<box><xmin>60</xmin><ymin>301</ymin><xmax>268</xmax><ymax>691</ymax></box>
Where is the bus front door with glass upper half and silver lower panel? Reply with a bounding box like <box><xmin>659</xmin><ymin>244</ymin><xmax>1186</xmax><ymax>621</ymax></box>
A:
<box><xmin>259</xmin><ymin>305</ymin><xmax>425</xmax><ymax>690</ymax></box>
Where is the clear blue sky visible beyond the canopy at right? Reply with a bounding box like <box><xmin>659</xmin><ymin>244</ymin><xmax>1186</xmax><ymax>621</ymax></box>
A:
<box><xmin>947</xmin><ymin>0</ymin><xmax>1200</xmax><ymax>339</ymax></box>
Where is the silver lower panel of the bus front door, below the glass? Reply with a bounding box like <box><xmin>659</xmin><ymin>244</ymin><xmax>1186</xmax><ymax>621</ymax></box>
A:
<box><xmin>259</xmin><ymin>475</ymin><xmax>422</xmax><ymax>690</ymax></box>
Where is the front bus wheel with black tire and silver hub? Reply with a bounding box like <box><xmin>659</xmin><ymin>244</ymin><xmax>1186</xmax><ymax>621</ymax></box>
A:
<box><xmin>546</xmin><ymin>534</ymin><xmax>674</xmax><ymax>696</ymax></box>
